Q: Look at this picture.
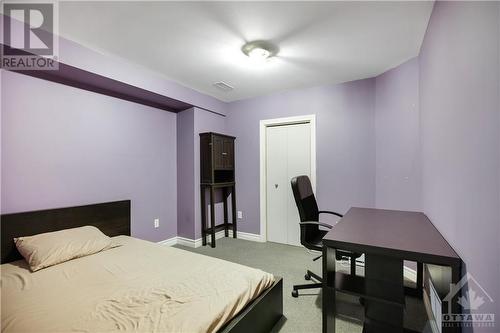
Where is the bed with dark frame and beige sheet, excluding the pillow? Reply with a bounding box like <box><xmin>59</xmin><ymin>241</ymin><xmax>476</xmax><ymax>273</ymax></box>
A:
<box><xmin>1</xmin><ymin>200</ymin><xmax>283</xmax><ymax>333</ymax></box>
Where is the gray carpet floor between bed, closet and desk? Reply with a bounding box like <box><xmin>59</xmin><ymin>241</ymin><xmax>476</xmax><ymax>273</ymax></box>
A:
<box><xmin>176</xmin><ymin>238</ymin><xmax>428</xmax><ymax>333</ymax></box>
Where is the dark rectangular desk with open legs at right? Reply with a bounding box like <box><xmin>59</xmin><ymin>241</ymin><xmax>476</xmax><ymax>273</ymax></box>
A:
<box><xmin>323</xmin><ymin>208</ymin><xmax>462</xmax><ymax>333</ymax></box>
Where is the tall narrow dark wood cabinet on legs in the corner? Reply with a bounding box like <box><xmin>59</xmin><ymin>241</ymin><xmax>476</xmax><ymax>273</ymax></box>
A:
<box><xmin>200</xmin><ymin>132</ymin><xmax>237</xmax><ymax>247</ymax></box>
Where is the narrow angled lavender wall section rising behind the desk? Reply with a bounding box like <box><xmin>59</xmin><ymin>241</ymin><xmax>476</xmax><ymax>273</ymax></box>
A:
<box><xmin>375</xmin><ymin>58</ymin><xmax>422</xmax><ymax>211</ymax></box>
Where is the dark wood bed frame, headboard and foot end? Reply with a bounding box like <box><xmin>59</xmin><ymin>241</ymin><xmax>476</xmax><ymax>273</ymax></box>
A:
<box><xmin>0</xmin><ymin>200</ymin><xmax>283</xmax><ymax>333</ymax></box>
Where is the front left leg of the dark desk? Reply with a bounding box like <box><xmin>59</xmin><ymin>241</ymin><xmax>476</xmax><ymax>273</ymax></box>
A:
<box><xmin>322</xmin><ymin>246</ymin><xmax>336</xmax><ymax>333</ymax></box>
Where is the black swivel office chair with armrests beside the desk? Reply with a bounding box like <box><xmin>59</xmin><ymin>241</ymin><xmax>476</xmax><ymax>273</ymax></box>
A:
<box><xmin>292</xmin><ymin>176</ymin><xmax>361</xmax><ymax>297</ymax></box>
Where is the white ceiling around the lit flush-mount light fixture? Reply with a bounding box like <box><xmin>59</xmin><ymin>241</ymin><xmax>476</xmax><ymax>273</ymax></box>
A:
<box><xmin>59</xmin><ymin>1</ymin><xmax>433</xmax><ymax>101</ymax></box>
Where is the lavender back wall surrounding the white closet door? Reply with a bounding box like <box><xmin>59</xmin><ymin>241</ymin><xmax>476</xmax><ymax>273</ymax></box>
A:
<box><xmin>226</xmin><ymin>79</ymin><xmax>375</xmax><ymax>234</ymax></box>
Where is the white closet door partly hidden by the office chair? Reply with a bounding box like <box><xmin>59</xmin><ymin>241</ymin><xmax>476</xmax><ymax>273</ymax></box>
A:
<box><xmin>266</xmin><ymin>123</ymin><xmax>311</xmax><ymax>245</ymax></box>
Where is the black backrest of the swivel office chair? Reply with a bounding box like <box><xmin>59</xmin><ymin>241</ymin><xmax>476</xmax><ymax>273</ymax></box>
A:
<box><xmin>291</xmin><ymin>176</ymin><xmax>320</xmax><ymax>248</ymax></box>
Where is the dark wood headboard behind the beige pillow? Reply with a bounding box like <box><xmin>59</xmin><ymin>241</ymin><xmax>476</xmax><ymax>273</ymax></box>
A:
<box><xmin>0</xmin><ymin>200</ymin><xmax>130</xmax><ymax>264</ymax></box>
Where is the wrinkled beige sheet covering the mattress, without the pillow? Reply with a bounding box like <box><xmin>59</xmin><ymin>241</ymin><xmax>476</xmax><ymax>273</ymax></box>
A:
<box><xmin>1</xmin><ymin>236</ymin><xmax>274</xmax><ymax>332</ymax></box>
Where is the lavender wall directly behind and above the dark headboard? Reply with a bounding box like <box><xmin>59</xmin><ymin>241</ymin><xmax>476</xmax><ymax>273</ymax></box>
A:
<box><xmin>1</xmin><ymin>72</ymin><xmax>177</xmax><ymax>241</ymax></box>
